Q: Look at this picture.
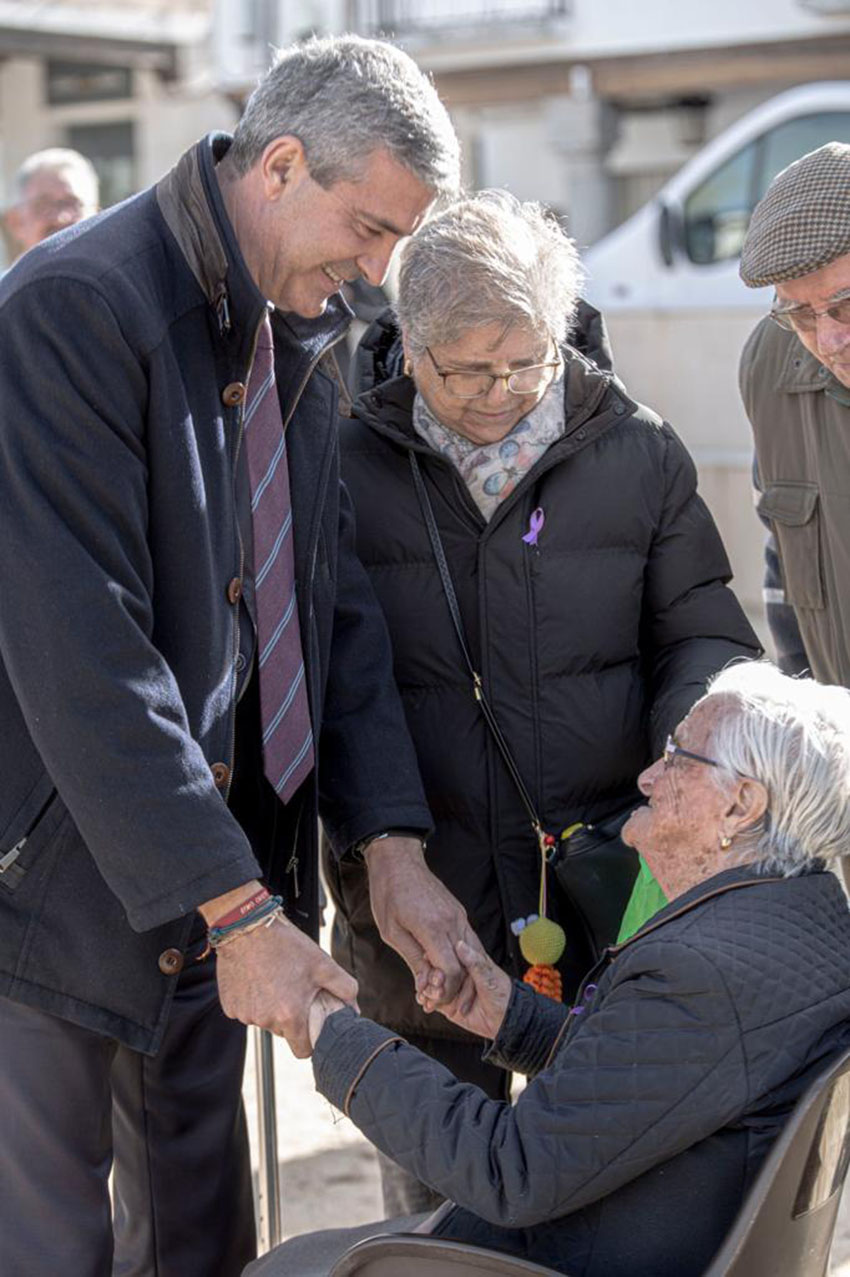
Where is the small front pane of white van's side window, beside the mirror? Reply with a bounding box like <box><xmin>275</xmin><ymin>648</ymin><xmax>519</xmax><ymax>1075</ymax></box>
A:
<box><xmin>684</xmin><ymin>139</ymin><xmax>758</xmax><ymax>266</ymax></box>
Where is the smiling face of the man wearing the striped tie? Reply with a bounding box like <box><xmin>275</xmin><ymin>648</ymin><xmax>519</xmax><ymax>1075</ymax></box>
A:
<box><xmin>251</xmin><ymin>149</ymin><xmax>434</xmax><ymax>319</ymax></box>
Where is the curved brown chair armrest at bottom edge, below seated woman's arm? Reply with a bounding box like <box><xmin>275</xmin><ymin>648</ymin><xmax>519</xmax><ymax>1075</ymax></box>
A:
<box><xmin>329</xmin><ymin>1232</ymin><xmax>558</xmax><ymax>1277</ymax></box>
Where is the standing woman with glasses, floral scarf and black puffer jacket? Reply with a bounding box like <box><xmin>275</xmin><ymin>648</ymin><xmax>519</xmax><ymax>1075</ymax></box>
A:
<box><xmin>327</xmin><ymin>192</ymin><xmax>757</xmax><ymax>1213</ymax></box>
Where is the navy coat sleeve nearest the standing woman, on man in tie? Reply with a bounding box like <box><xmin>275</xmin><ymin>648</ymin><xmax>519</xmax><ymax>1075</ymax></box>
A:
<box><xmin>313</xmin><ymin>484</ymin><xmax>431</xmax><ymax>854</ymax></box>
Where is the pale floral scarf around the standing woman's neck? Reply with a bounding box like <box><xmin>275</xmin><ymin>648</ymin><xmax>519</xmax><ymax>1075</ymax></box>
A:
<box><xmin>414</xmin><ymin>375</ymin><xmax>565</xmax><ymax>522</ymax></box>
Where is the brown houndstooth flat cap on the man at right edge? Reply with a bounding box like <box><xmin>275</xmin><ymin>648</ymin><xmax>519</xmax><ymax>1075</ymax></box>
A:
<box><xmin>740</xmin><ymin>142</ymin><xmax>850</xmax><ymax>289</ymax></box>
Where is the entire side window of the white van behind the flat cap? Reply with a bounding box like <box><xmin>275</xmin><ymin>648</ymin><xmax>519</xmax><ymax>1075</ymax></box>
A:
<box><xmin>683</xmin><ymin>111</ymin><xmax>850</xmax><ymax>266</ymax></box>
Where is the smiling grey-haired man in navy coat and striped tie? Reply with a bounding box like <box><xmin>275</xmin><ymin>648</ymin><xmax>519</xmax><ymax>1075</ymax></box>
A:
<box><xmin>0</xmin><ymin>38</ymin><xmax>463</xmax><ymax>1277</ymax></box>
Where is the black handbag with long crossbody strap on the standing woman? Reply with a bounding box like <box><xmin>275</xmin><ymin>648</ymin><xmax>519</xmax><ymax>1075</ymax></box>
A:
<box><xmin>408</xmin><ymin>452</ymin><xmax>639</xmax><ymax>956</ymax></box>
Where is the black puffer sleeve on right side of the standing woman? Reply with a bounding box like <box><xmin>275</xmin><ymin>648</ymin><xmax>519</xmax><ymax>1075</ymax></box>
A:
<box><xmin>642</xmin><ymin>423</ymin><xmax>761</xmax><ymax>755</ymax></box>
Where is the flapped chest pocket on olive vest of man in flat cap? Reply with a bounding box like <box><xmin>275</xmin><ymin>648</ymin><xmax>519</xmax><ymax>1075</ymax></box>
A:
<box><xmin>758</xmin><ymin>480</ymin><xmax>823</xmax><ymax>608</ymax></box>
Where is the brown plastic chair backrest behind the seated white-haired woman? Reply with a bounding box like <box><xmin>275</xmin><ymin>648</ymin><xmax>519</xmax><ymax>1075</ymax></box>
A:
<box><xmin>705</xmin><ymin>1051</ymin><xmax>850</xmax><ymax>1277</ymax></box>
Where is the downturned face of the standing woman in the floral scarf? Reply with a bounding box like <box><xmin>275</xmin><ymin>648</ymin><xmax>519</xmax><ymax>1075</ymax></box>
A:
<box><xmin>408</xmin><ymin>323</ymin><xmax>556</xmax><ymax>444</ymax></box>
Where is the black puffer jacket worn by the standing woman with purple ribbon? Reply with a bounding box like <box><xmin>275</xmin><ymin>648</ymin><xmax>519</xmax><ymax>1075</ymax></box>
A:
<box><xmin>327</xmin><ymin>311</ymin><xmax>757</xmax><ymax>1036</ymax></box>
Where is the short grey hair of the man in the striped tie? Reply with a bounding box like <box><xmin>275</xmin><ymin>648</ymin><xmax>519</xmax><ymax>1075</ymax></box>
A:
<box><xmin>227</xmin><ymin>36</ymin><xmax>461</xmax><ymax>197</ymax></box>
